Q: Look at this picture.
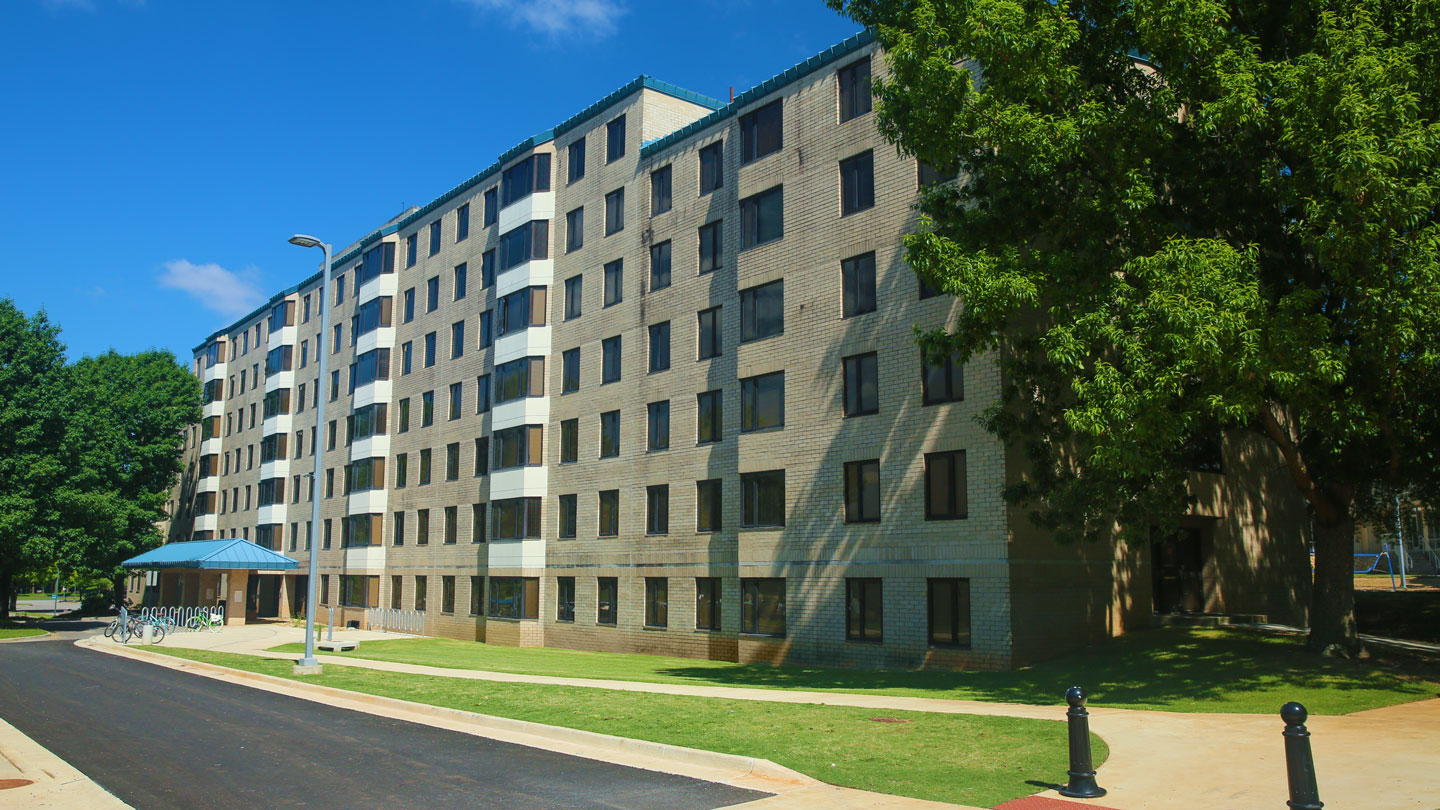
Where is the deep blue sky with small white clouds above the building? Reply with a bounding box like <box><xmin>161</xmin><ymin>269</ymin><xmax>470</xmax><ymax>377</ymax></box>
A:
<box><xmin>0</xmin><ymin>0</ymin><xmax>858</xmax><ymax>360</ymax></box>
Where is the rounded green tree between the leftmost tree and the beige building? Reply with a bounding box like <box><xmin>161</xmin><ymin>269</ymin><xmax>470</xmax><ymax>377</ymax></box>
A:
<box><xmin>56</xmin><ymin>350</ymin><xmax>200</xmax><ymax>607</ymax></box>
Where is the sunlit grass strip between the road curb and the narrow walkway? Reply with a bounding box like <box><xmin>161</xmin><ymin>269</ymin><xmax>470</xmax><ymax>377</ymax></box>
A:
<box><xmin>150</xmin><ymin>647</ymin><xmax>1088</xmax><ymax>807</ymax></box>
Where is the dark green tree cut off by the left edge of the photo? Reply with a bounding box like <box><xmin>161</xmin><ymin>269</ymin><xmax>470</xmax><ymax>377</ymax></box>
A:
<box><xmin>0</xmin><ymin>298</ymin><xmax>65</xmax><ymax>618</ymax></box>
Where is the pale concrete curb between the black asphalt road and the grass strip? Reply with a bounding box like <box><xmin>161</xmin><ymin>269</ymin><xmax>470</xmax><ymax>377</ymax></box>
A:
<box><xmin>75</xmin><ymin>638</ymin><xmax>824</xmax><ymax>793</ymax></box>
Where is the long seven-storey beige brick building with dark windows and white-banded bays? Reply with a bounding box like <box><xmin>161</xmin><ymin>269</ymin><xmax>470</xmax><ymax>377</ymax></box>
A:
<box><xmin>170</xmin><ymin>35</ymin><xmax>1303</xmax><ymax>669</ymax></box>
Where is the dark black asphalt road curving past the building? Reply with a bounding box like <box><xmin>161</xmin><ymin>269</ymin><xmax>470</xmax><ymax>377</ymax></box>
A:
<box><xmin>0</xmin><ymin>640</ymin><xmax>765</xmax><ymax>810</ymax></box>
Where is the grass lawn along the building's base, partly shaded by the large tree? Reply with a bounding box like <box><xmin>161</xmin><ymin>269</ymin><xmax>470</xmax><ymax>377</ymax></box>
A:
<box><xmin>275</xmin><ymin>627</ymin><xmax>1440</xmax><ymax>715</ymax></box>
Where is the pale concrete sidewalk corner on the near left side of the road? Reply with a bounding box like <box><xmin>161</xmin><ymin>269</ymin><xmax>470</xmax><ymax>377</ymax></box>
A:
<box><xmin>0</xmin><ymin>718</ymin><xmax>132</xmax><ymax>810</ymax></box>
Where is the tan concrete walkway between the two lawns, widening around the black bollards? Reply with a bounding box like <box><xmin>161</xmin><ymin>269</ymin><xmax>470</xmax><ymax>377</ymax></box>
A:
<box><xmin>109</xmin><ymin>626</ymin><xmax>1440</xmax><ymax>810</ymax></box>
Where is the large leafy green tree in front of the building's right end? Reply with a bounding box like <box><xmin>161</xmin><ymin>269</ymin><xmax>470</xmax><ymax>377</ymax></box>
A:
<box><xmin>829</xmin><ymin>0</ymin><xmax>1440</xmax><ymax>651</ymax></box>
